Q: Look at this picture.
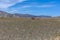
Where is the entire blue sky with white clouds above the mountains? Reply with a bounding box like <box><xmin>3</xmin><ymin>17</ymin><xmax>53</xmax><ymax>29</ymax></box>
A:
<box><xmin>0</xmin><ymin>0</ymin><xmax>60</xmax><ymax>16</ymax></box>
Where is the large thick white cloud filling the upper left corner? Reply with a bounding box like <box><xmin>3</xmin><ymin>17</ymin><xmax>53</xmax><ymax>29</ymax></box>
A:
<box><xmin>0</xmin><ymin>0</ymin><xmax>26</xmax><ymax>9</ymax></box>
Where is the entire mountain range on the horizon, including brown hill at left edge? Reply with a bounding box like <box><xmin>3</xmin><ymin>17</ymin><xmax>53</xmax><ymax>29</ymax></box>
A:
<box><xmin>0</xmin><ymin>11</ymin><xmax>51</xmax><ymax>18</ymax></box>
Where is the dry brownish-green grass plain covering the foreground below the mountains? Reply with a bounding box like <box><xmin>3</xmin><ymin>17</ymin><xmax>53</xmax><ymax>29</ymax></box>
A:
<box><xmin>0</xmin><ymin>18</ymin><xmax>60</xmax><ymax>40</ymax></box>
